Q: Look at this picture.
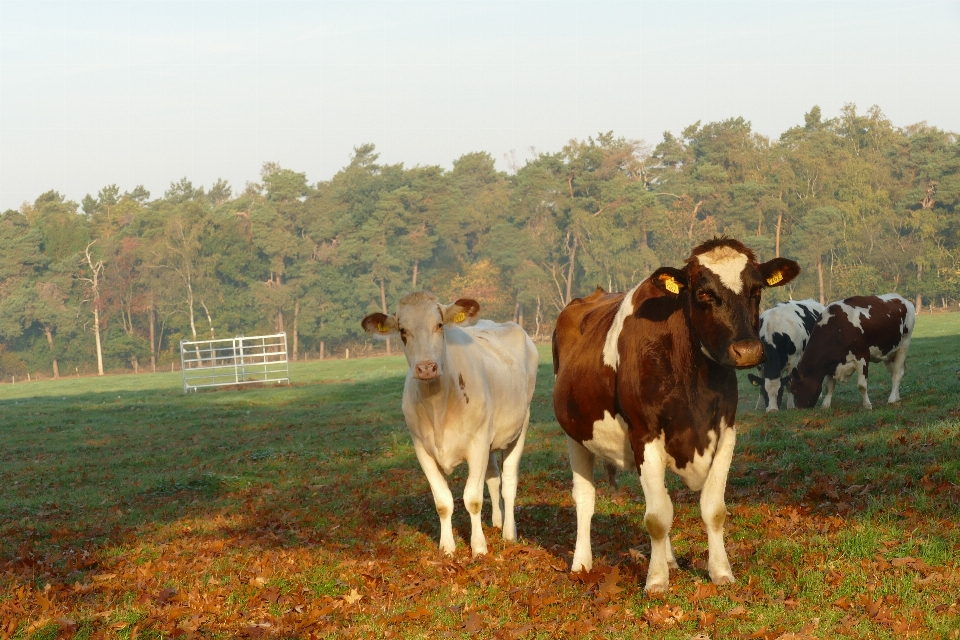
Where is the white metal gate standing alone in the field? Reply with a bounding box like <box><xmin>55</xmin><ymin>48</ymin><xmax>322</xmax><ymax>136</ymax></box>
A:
<box><xmin>180</xmin><ymin>333</ymin><xmax>290</xmax><ymax>393</ymax></box>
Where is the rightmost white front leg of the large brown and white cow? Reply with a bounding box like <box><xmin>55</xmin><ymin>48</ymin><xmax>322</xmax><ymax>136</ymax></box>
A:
<box><xmin>700</xmin><ymin>422</ymin><xmax>737</xmax><ymax>585</ymax></box>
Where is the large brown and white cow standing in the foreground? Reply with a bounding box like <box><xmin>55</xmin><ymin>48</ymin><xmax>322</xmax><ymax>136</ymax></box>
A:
<box><xmin>553</xmin><ymin>238</ymin><xmax>800</xmax><ymax>592</ymax></box>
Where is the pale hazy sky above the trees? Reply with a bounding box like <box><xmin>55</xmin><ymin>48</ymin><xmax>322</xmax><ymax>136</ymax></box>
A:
<box><xmin>0</xmin><ymin>0</ymin><xmax>960</xmax><ymax>211</ymax></box>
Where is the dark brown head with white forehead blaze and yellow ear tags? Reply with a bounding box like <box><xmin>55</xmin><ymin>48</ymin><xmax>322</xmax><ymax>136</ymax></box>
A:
<box><xmin>650</xmin><ymin>238</ymin><xmax>800</xmax><ymax>369</ymax></box>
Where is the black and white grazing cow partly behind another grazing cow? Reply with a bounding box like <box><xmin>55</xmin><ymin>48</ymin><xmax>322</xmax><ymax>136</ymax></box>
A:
<box><xmin>747</xmin><ymin>299</ymin><xmax>823</xmax><ymax>412</ymax></box>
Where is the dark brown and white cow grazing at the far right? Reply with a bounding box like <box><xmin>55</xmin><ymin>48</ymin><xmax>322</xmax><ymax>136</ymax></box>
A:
<box><xmin>790</xmin><ymin>293</ymin><xmax>917</xmax><ymax>409</ymax></box>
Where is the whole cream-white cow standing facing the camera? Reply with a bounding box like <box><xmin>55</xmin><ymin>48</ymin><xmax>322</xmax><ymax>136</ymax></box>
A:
<box><xmin>362</xmin><ymin>291</ymin><xmax>540</xmax><ymax>556</ymax></box>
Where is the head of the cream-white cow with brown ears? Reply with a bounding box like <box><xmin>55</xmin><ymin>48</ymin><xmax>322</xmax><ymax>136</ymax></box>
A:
<box><xmin>361</xmin><ymin>291</ymin><xmax>480</xmax><ymax>380</ymax></box>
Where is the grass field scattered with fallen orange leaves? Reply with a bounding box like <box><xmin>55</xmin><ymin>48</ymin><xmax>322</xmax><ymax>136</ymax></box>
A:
<box><xmin>0</xmin><ymin>314</ymin><xmax>960</xmax><ymax>640</ymax></box>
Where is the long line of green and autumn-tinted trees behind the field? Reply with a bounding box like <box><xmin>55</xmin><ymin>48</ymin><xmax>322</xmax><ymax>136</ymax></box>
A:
<box><xmin>0</xmin><ymin>105</ymin><xmax>960</xmax><ymax>377</ymax></box>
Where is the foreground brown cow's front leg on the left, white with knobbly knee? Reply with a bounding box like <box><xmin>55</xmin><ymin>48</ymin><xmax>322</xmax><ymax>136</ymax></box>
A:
<box><xmin>640</xmin><ymin>440</ymin><xmax>676</xmax><ymax>593</ymax></box>
